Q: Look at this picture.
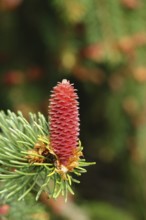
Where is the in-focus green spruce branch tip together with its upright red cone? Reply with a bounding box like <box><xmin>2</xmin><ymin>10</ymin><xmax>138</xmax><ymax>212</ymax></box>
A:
<box><xmin>0</xmin><ymin>80</ymin><xmax>92</xmax><ymax>201</ymax></box>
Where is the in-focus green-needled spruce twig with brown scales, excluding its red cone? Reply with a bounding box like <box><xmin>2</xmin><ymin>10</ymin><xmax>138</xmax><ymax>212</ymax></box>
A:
<box><xmin>0</xmin><ymin>80</ymin><xmax>94</xmax><ymax>201</ymax></box>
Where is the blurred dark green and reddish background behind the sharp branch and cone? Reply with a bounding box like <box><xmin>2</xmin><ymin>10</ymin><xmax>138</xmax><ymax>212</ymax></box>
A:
<box><xmin>0</xmin><ymin>0</ymin><xmax>146</xmax><ymax>220</ymax></box>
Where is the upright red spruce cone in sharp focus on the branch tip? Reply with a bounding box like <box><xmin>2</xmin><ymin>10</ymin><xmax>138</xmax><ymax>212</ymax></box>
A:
<box><xmin>49</xmin><ymin>79</ymin><xmax>79</xmax><ymax>165</ymax></box>
